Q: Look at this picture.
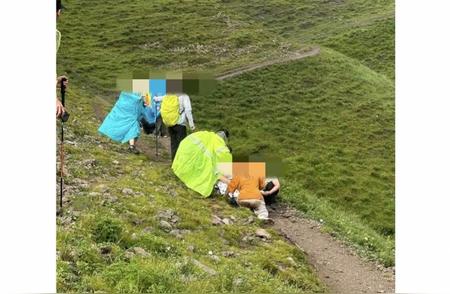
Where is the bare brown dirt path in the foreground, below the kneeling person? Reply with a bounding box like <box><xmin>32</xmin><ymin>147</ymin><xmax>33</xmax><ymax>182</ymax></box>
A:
<box><xmin>269</xmin><ymin>204</ymin><xmax>395</xmax><ymax>294</ymax></box>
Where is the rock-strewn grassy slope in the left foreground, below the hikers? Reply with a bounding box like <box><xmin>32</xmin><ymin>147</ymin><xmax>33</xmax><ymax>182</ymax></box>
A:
<box><xmin>57</xmin><ymin>85</ymin><xmax>324</xmax><ymax>293</ymax></box>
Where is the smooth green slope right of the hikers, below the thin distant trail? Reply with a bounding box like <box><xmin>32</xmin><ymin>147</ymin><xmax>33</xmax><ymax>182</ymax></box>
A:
<box><xmin>193</xmin><ymin>49</ymin><xmax>395</xmax><ymax>263</ymax></box>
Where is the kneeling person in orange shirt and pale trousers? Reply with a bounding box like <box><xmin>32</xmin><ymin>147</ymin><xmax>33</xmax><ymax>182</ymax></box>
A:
<box><xmin>227</xmin><ymin>176</ymin><xmax>270</xmax><ymax>221</ymax></box>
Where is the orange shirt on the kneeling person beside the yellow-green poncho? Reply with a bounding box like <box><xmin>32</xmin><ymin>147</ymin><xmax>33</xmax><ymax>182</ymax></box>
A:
<box><xmin>227</xmin><ymin>176</ymin><xmax>264</xmax><ymax>200</ymax></box>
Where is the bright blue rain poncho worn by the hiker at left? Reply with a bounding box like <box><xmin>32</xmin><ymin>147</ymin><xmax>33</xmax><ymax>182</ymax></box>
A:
<box><xmin>98</xmin><ymin>92</ymin><xmax>144</xmax><ymax>143</ymax></box>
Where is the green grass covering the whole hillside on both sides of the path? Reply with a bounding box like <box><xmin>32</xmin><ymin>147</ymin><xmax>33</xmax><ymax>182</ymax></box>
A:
<box><xmin>57</xmin><ymin>0</ymin><xmax>395</xmax><ymax>293</ymax></box>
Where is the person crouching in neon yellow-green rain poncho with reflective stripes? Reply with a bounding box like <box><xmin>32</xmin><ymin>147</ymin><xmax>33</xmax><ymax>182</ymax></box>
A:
<box><xmin>172</xmin><ymin>130</ymin><xmax>232</xmax><ymax>197</ymax></box>
